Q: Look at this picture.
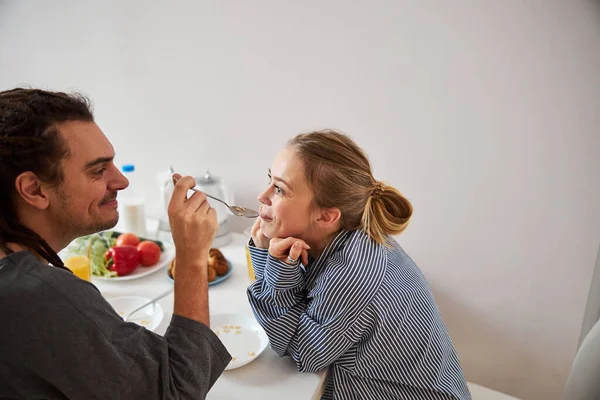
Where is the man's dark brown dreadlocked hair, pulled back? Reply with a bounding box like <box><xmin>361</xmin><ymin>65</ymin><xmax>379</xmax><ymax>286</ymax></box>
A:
<box><xmin>0</xmin><ymin>88</ymin><xmax>94</xmax><ymax>267</ymax></box>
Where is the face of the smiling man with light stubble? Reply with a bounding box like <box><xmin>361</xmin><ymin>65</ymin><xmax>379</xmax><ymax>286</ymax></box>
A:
<box><xmin>48</xmin><ymin>121</ymin><xmax>129</xmax><ymax>237</ymax></box>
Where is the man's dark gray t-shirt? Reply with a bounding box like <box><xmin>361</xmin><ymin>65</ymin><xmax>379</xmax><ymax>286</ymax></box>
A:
<box><xmin>0</xmin><ymin>251</ymin><xmax>231</xmax><ymax>400</ymax></box>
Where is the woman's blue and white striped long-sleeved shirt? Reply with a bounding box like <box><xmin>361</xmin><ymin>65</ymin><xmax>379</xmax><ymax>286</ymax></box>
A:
<box><xmin>248</xmin><ymin>230</ymin><xmax>471</xmax><ymax>400</ymax></box>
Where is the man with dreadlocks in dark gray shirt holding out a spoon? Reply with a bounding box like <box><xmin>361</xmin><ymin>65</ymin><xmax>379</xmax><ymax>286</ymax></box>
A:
<box><xmin>0</xmin><ymin>89</ymin><xmax>231</xmax><ymax>399</ymax></box>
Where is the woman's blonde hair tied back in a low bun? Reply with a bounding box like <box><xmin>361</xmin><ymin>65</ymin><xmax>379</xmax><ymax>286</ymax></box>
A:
<box><xmin>288</xmin><ymin>130</ymin><xmax>413</xmax><ymax>244</ymax></box>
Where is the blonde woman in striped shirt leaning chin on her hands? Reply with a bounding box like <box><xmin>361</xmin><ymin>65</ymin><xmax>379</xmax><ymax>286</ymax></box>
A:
<box><xmin>248</xmin><ymin>131</ymin><xmax>470</xmax><ymax>400</ymax></box>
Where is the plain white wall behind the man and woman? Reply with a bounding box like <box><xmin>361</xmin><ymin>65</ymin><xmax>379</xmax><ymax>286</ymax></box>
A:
<box><xmin>0</xmin><ymin>0</ymin><xmax>600</xmax><ymax>399</ymax></box>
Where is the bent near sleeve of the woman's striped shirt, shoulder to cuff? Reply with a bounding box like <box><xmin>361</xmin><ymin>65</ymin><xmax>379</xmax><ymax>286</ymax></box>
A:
<box><xmin>248</xmin><ymin>236</ymin><xmax>385</xmax><ymax>372</ymax></box>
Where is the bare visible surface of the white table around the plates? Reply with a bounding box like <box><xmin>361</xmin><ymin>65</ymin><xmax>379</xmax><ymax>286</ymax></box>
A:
<box><xmin>93</xmin><ymin>233</ymin><xmax>320</xmax><ymax>400</ymax></box>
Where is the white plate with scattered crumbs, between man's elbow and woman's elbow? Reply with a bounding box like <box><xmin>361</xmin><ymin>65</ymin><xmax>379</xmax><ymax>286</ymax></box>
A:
<box><xmin>210</xmin><ymin>314</ymin><xmax>269</xmax><ymax>370</ymax></box>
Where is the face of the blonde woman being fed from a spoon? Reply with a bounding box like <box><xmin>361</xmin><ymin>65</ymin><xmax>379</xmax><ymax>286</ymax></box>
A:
<box><xmin>258</xmin><ymin>147</ymin><xmax>315</xmax><ymax>240</ymax></box>
